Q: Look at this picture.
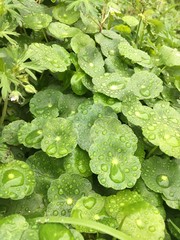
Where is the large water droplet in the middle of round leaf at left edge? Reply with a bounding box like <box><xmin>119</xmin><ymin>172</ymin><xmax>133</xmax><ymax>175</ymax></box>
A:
<box><xmin>2</xmin><ymin>170</ymin><xmax>24</xmax><ymax>188</ymax></box>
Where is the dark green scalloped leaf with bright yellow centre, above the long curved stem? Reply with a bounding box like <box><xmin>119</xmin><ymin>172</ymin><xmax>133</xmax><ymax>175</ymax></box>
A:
<box><xmin>47</xmin><ymin>173</ymin><xmax>92</xmax><ymax>216</ymax></box>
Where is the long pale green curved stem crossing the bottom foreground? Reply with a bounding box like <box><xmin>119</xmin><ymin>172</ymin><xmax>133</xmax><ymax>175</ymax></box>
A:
<box><xmin>36</xmin><ymin>216</ymin><xmax>136</xmax><ymax>240</ymax></box>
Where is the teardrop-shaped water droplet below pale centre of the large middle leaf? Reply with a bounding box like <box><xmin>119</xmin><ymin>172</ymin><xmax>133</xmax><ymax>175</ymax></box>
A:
<box><xmin>109</xmin><ymin>164</ymin><xmax>125</xmax><ymax>183</ymax></box>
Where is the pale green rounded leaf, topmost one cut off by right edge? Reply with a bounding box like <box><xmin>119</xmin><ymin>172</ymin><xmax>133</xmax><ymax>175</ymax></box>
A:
<box><xmin>159</xmin><ymin>46</ymin><xmax>180</xmax><ymax>67</ymax></box>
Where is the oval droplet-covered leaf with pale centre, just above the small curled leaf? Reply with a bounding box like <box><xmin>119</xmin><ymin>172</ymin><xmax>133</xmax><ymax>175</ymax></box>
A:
<box><xmin>77</xmin><ymin>45</ymin><xmax>104</xmax><ymax>77</ymax></box>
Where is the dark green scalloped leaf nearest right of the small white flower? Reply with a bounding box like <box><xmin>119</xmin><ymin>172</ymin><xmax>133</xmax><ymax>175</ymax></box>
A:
<box><xmin>29</xmin><ymin>89</ymin><xmax>63</xmax><ymax>118</ymax></box>
